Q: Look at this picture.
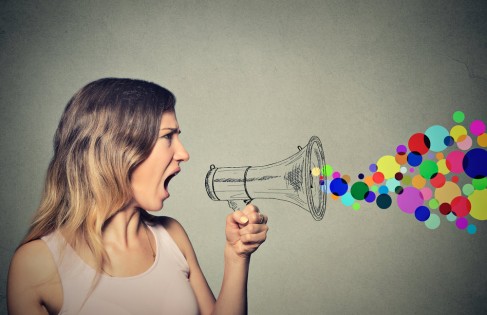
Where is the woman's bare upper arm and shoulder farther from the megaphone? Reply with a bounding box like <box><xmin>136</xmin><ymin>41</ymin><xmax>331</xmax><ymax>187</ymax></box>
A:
<box><xmin>7</xmin><ymin>240</ymin><xmax>62</xmax><ymax>315</ymax></box>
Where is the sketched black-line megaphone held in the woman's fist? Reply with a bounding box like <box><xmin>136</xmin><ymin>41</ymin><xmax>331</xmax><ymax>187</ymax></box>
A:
<box><xmin>205</xmin><ymin>136</ymin><xmax>327</xmax><ymax>221</ymax></box>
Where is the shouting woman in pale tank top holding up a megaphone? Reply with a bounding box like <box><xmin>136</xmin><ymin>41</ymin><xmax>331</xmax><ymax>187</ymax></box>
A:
<box><xmin>8</xmin><ymin>78</ymin><xmax>268</xmax><ymax>315</ymax></box>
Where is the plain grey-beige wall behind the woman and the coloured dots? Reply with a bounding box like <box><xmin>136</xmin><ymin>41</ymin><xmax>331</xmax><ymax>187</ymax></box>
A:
<box><xmin>0</xmin><ymin>1</ymin><xmax>487</xmax><ymax>314</ymax></box>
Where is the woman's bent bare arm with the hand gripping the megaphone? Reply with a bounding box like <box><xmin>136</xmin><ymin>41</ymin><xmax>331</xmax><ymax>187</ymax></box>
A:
<box><xmin>167</xmin><ymin>205</ymin><xmax>268</xmax><ymax>314</ymax></box>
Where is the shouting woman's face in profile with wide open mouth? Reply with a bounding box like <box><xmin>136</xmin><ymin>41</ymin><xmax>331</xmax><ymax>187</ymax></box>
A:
<box><xmin>131</xmin><ymin>112</ymin><xmax>189</xmax><ymax>211</ymax></box>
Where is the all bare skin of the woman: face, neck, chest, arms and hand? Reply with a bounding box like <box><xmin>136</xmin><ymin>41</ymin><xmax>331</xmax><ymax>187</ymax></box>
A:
<box><xmin>7</xmin><ymin>112</ymin><xmax>268</xmax><ymax>315</ymax></box>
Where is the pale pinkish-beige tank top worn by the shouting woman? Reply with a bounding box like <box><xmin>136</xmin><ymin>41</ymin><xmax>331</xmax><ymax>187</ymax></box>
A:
<box><xmin>42</xmin><ymin>225</ymin><xmax>198</xmax><ymax>315</ymax></box>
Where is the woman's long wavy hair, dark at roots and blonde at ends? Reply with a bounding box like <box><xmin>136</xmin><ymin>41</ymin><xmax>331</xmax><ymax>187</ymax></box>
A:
<box><xmin>22</xmin><ymin>78</ymin><xmax>175</xmax><ymax>272</ymax></box>
